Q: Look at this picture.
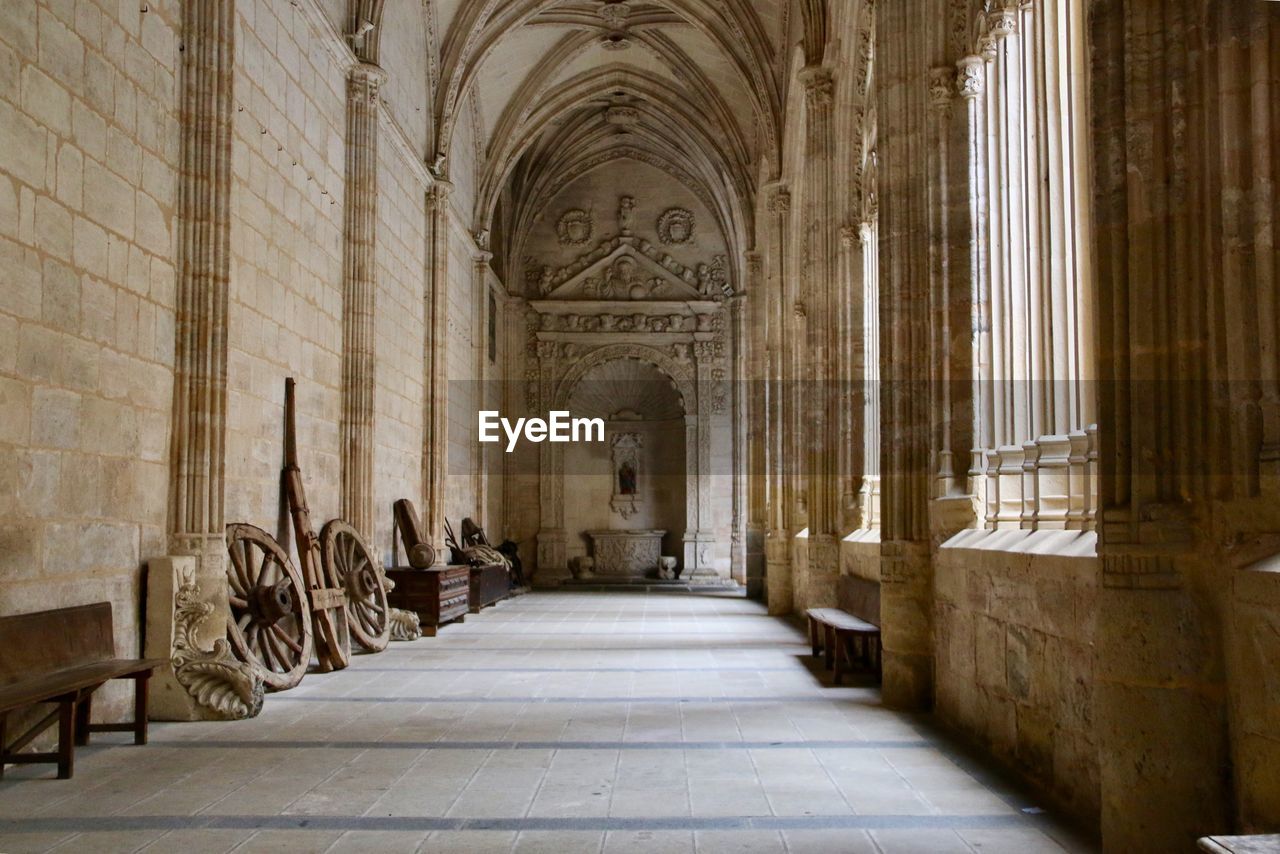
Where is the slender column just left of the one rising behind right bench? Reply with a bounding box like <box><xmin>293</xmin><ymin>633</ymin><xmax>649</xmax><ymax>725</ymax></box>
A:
<box><xmin>764</xmin><ymin>183</ymin><xmax>792</xmax><ymax>615</ymax></box>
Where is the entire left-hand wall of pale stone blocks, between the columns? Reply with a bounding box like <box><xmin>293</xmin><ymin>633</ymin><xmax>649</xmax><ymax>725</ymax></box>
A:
<box><xmin>0</xmin><ymin>0</ymin><xmax>500</xmax><ymax>714</ymax></box>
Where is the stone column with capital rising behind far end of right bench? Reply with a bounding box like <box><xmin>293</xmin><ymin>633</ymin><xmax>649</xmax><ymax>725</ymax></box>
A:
<box><xmin>800</xmin><ymin>65</ymin><xmax>841</xmax><ymax>607</ymax></box>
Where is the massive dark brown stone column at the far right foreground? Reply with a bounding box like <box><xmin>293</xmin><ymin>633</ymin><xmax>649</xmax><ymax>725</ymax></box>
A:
<box><xmin>1089</xmin><ymin>0</ymin><xmax>1280</xmax><ymax>851</ymax></box>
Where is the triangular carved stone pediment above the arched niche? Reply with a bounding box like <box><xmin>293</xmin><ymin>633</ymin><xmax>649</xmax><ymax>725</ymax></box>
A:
<box><xmin>544</xmin><ymin>241</ymin><xmax>705</xmax><ymax>301</ymax></box>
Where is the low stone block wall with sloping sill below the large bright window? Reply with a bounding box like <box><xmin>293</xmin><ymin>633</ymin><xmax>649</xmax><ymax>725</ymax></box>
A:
<box><xmin>934</xmin><ymin>530</ymin><xmax>1100</xmax><ymax>822</ymax></box>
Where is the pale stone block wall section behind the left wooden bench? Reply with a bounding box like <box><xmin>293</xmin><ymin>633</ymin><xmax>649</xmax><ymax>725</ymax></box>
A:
<box><xmin>0</xmin><ymin>0</ymin><xmax>180</xmax><ymax>701</ymax></box>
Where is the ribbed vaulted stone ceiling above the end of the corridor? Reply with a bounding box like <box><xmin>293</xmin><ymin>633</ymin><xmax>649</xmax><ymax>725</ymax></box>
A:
<box><xmin>352</xmin><ymin>0</ymin><xmax>788</xmax><ymax>286</ymax></box>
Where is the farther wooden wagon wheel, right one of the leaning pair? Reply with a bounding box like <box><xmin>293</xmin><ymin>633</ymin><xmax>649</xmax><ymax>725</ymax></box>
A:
<box><xmin>320</xmin><ymin>519</ymin><xmax>392</xmax><ymax>653</ymax></box>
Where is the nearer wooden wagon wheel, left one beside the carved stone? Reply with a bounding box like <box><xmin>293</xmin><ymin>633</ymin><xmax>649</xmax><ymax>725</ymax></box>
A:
<box><xmin>227</xmin><ymin>524</ymin><xmax>312</xmax><ymax>691</ymax></box>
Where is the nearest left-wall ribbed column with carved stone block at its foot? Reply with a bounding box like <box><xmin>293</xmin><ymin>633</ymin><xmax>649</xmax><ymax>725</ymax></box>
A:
<box><xmin>156</xmin><ymin>0</ymin><xmax>262</xmax><ymax>721</ymax></box>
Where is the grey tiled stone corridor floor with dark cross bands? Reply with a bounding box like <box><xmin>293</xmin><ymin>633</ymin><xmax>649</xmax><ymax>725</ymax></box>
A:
<box><xmin>0</xmin><ymin>593</ymin><xmax>1091</xmax><ymax>854</ymax></box>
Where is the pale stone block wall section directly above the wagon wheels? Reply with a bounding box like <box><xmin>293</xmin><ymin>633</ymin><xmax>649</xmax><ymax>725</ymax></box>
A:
<box><xmin>227</xmin><ymin>0</ymin><xmax>347</xmax><ymax>531</ymax></box>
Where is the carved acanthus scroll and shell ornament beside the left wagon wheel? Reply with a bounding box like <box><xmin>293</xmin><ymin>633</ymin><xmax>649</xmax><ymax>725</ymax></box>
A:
<box><xmin>169</xmin><ymin>581</ymin><xmax>264</xmax><ymax>721</ymax></box>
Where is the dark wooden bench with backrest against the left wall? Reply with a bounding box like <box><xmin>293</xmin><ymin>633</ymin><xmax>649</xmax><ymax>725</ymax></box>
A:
<box><xmin>0</xmin><ymin>602</ymin><xmax>169</xmax><ymax>780</ymax></box>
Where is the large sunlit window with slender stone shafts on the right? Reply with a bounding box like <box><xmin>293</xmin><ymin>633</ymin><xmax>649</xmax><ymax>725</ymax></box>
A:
<box><xmin>960</xmin><ymin>0</ymin><xmax>1097</xmax><ymax>530</ymax></box>
